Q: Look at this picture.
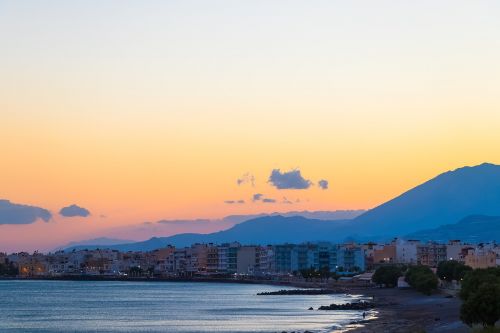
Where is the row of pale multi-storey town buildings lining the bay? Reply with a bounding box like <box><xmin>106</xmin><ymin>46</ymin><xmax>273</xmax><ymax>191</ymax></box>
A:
<box><xmin>0</xmin><ymin>239</ymin><xmax>500</xmax><ymax>279</ymax></box>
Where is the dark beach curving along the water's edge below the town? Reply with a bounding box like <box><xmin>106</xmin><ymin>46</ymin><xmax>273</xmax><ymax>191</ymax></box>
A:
<box><xmin>0</xmin><ymin>276</ymin><xmax>469</xmax><ymax>333</ymax></box>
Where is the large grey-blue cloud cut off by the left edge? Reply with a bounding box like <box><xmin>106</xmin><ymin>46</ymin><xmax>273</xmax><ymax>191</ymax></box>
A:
<box><xmin>0</xmin><ymin>200</ymin><xmax>52</xmax><ymax>224</ymax></box>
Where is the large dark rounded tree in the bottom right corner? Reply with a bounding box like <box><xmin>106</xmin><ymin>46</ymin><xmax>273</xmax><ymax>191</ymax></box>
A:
<box><xmin>460</xmin><ymin>282</ymin><xmax>500</xmax><ymax>326</ymax></box>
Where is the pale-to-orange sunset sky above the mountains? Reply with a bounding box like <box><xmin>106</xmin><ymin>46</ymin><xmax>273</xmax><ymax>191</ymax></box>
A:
<box><xmin>0</xmin><ymin>0</ymin><xmax>500</xmax><ymax>251</ymax></box>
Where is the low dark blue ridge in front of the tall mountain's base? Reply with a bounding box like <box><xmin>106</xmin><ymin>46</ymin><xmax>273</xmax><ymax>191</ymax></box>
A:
<box><xmin>403</xmin><ymin>215</ymin><xmax>500</xmax><ymax>244</ymax></box>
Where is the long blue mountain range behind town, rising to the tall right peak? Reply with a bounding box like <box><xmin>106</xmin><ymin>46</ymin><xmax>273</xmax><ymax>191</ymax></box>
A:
<box><xmin>63</xmin><ymin>163</ymin><xmax>500</xmax><ymax>251</ymax></box>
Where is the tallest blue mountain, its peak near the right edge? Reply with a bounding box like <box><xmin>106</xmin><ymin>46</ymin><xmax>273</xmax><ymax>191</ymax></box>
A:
<box><xmin>352</xmin><ymin>163</ymin><xmax>500</xmax><ymax>239</ymax></box>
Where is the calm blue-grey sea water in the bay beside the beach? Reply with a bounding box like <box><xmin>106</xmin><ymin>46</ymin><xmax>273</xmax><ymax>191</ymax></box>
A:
<box><xmin>0</xmin><ymin>281</ymin><xmax>368</xmax><ymax>333</ymax></box>
